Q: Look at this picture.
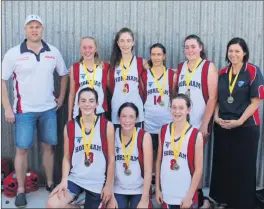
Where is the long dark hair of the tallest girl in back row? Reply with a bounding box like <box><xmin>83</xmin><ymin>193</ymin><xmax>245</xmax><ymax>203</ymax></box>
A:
<box><xmin>110</xmin><ymin>28</ymin><xmax>134</xmax><ymax>69</ymax></box>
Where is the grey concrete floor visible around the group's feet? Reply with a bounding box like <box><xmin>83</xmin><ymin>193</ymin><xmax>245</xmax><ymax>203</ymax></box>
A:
<box><xmin>1</xmin><ymin>187</ymin><xmax>209</xmax><ymax>208</ymax></box>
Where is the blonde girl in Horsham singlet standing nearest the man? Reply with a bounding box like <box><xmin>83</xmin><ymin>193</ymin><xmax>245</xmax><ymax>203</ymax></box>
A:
<box><xmin>68</xmin><ymin>36</ymin><xmax>109</xmax><ymax>121</ymax></box>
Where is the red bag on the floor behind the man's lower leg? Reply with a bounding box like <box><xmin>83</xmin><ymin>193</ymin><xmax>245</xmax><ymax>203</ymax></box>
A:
<box><xmin>4</xmin><ymin>171</ymin><xmax>39</xmax><ymax>197</ymax></box>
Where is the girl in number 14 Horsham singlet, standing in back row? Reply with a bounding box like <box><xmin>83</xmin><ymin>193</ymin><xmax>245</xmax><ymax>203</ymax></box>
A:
<box><xmin>142</xmin><ymin>43</ymin><xmax>175</xmax><ymax>168</ymax></box>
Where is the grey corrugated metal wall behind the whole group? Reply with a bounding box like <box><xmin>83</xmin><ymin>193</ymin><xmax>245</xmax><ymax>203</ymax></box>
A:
<box><xmin>1</xmin><ymin>1</ymin><xmax>264</xmax><ymax>187</ymax></box>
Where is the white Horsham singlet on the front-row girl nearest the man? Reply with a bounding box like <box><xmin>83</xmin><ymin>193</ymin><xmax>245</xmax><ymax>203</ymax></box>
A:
<box><xmin>68</xmin><ymin>117</ymin><xmax>106</xmax><ymax>193</ymax></box>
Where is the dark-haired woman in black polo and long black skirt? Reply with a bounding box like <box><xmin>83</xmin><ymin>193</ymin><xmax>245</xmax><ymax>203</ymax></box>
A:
<box><xmin>210</xmin><ymin>38</ymin><xmax>264</xmax><ymax>208</ymax></box>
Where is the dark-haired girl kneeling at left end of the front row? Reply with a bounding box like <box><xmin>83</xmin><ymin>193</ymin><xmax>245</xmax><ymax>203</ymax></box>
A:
<box><xmin>47</xmin><ymin>87</ymin><xmax>115</xmax><ymax>208</ymax></box>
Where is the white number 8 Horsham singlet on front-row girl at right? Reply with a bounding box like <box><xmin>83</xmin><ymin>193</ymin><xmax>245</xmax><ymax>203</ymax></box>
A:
<box><xmin>160</xmin><ymin>124</ymin><xmax>193</xmax><ymax>205</ymax></box>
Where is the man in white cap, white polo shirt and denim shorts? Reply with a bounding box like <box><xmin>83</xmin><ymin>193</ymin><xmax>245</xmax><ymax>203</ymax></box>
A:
<box><xmin>2</xmin><ymin>15</ymin><xmax>68</xmax><ymax>207</ymax></box>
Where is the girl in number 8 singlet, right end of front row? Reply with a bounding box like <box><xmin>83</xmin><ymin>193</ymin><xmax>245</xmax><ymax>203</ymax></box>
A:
<box><xmin>156</xmin><ymin>94</ymin><xmax>203</xmax><ymax>208</ymax></box>
